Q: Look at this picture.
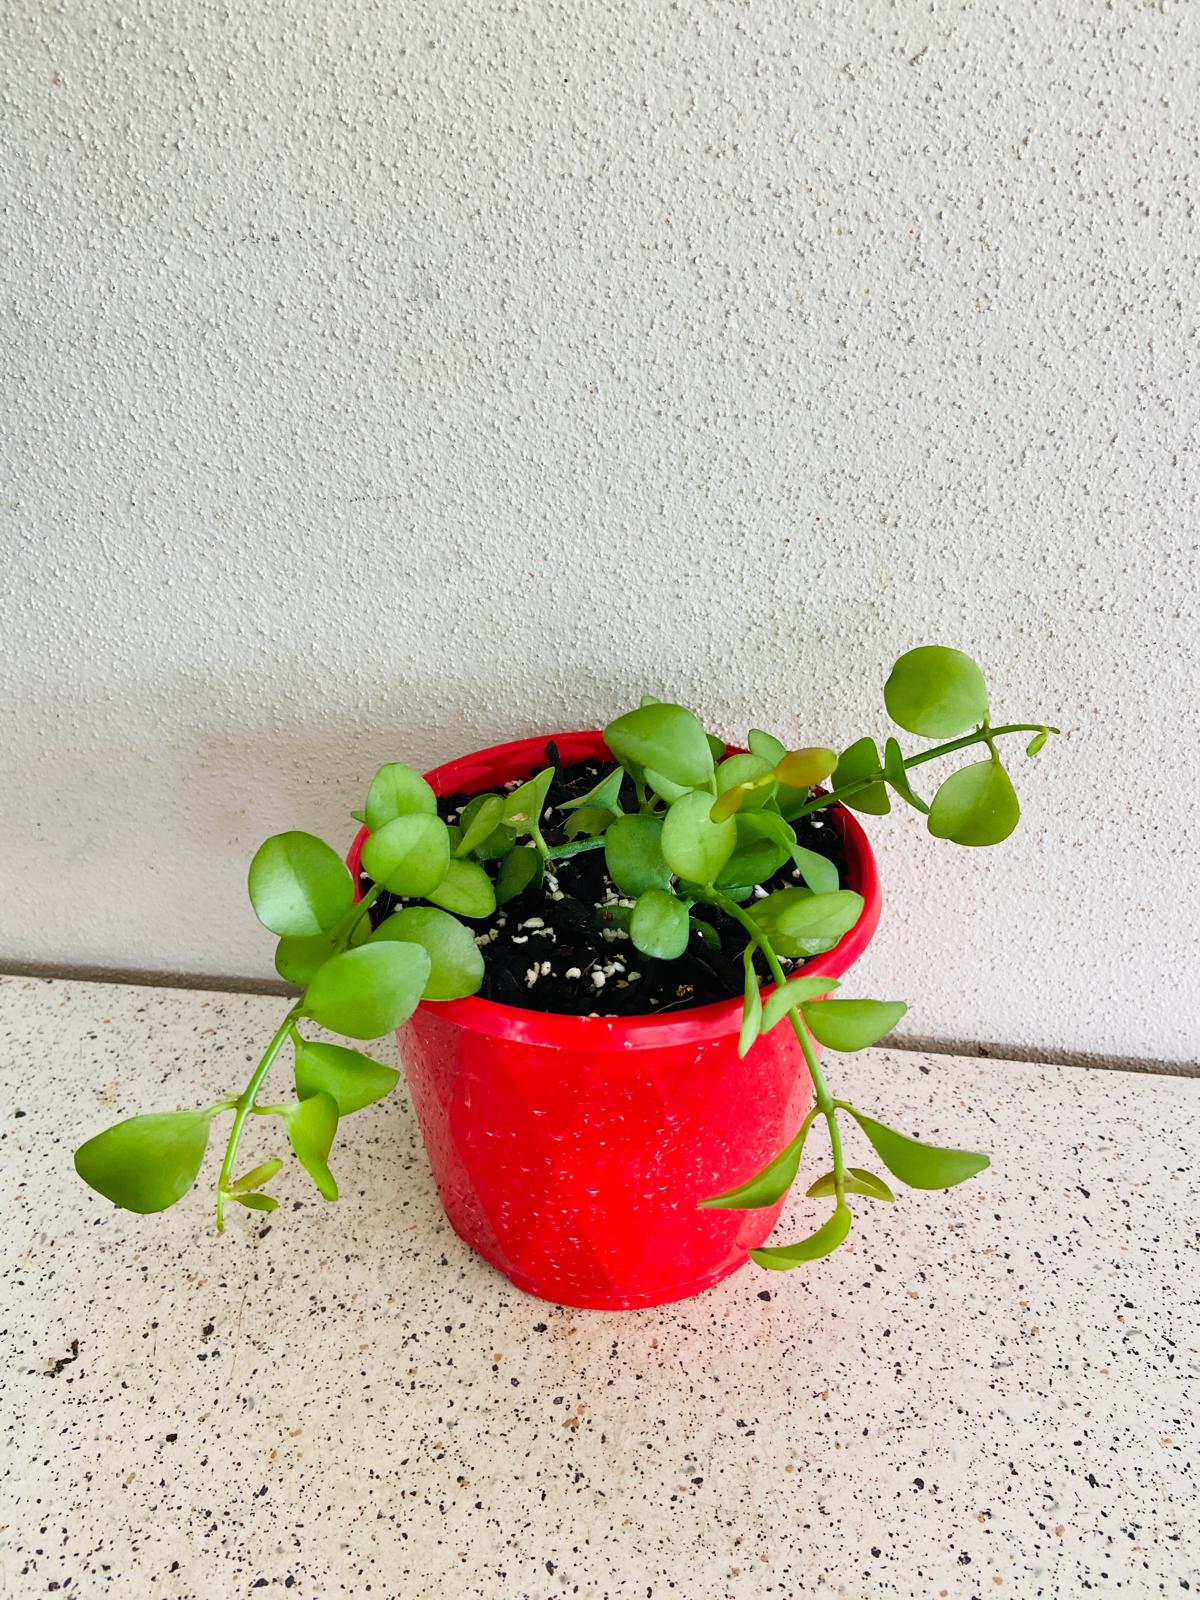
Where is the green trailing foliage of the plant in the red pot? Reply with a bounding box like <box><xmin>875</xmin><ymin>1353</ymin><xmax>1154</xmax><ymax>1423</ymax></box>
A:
<box><xmin>75</xmin><ymin>645</ymin><xmax>1058</xmax><ymax>1272</ymax></box>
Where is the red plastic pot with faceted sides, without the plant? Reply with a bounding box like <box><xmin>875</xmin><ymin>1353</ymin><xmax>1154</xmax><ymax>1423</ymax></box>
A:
<box><xmin>347</xmin><ymin>733</ymin><xmax>880</xmax><ymax>1310</ymax></box>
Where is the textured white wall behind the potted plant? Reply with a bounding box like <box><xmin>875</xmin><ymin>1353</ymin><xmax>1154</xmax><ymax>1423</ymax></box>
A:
<box><xmin>0</xmin><ymin>0</ymin><xmax>1200</xmax><ymax>1059</ymax></box>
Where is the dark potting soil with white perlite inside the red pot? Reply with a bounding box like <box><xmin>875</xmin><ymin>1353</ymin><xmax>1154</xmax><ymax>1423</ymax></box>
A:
<box><xmin>362</xmin><ymin>742</ymin><xmax>848</xmax><ymax>1016</ymax></box>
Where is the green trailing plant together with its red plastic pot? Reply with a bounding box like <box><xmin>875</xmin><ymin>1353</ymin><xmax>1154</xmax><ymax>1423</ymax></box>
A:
<box><xmin>75</xmin><ymin>646</ymin><xmax>1058</xmax><ymax>1307</ymax></box>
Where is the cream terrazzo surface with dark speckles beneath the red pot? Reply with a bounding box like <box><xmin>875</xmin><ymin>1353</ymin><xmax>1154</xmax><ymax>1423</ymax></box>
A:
<box><xmin>0</xmin><ymin>979</ymin><xmax>1200</xmax><ymax>1600</ymax></box>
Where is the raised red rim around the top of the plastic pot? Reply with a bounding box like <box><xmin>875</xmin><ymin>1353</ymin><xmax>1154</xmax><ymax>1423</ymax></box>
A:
<box><xmin>346</xmin><ymin>728</ymin><xmax>883</xmax><ymax>1050</ymax></box>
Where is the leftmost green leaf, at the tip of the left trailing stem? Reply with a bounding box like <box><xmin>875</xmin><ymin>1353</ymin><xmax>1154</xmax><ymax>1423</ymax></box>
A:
<box><xmin>75</xmin><ymin>1110</ymin><xmax>213</xmax><ymax>1214</ymax></box>
